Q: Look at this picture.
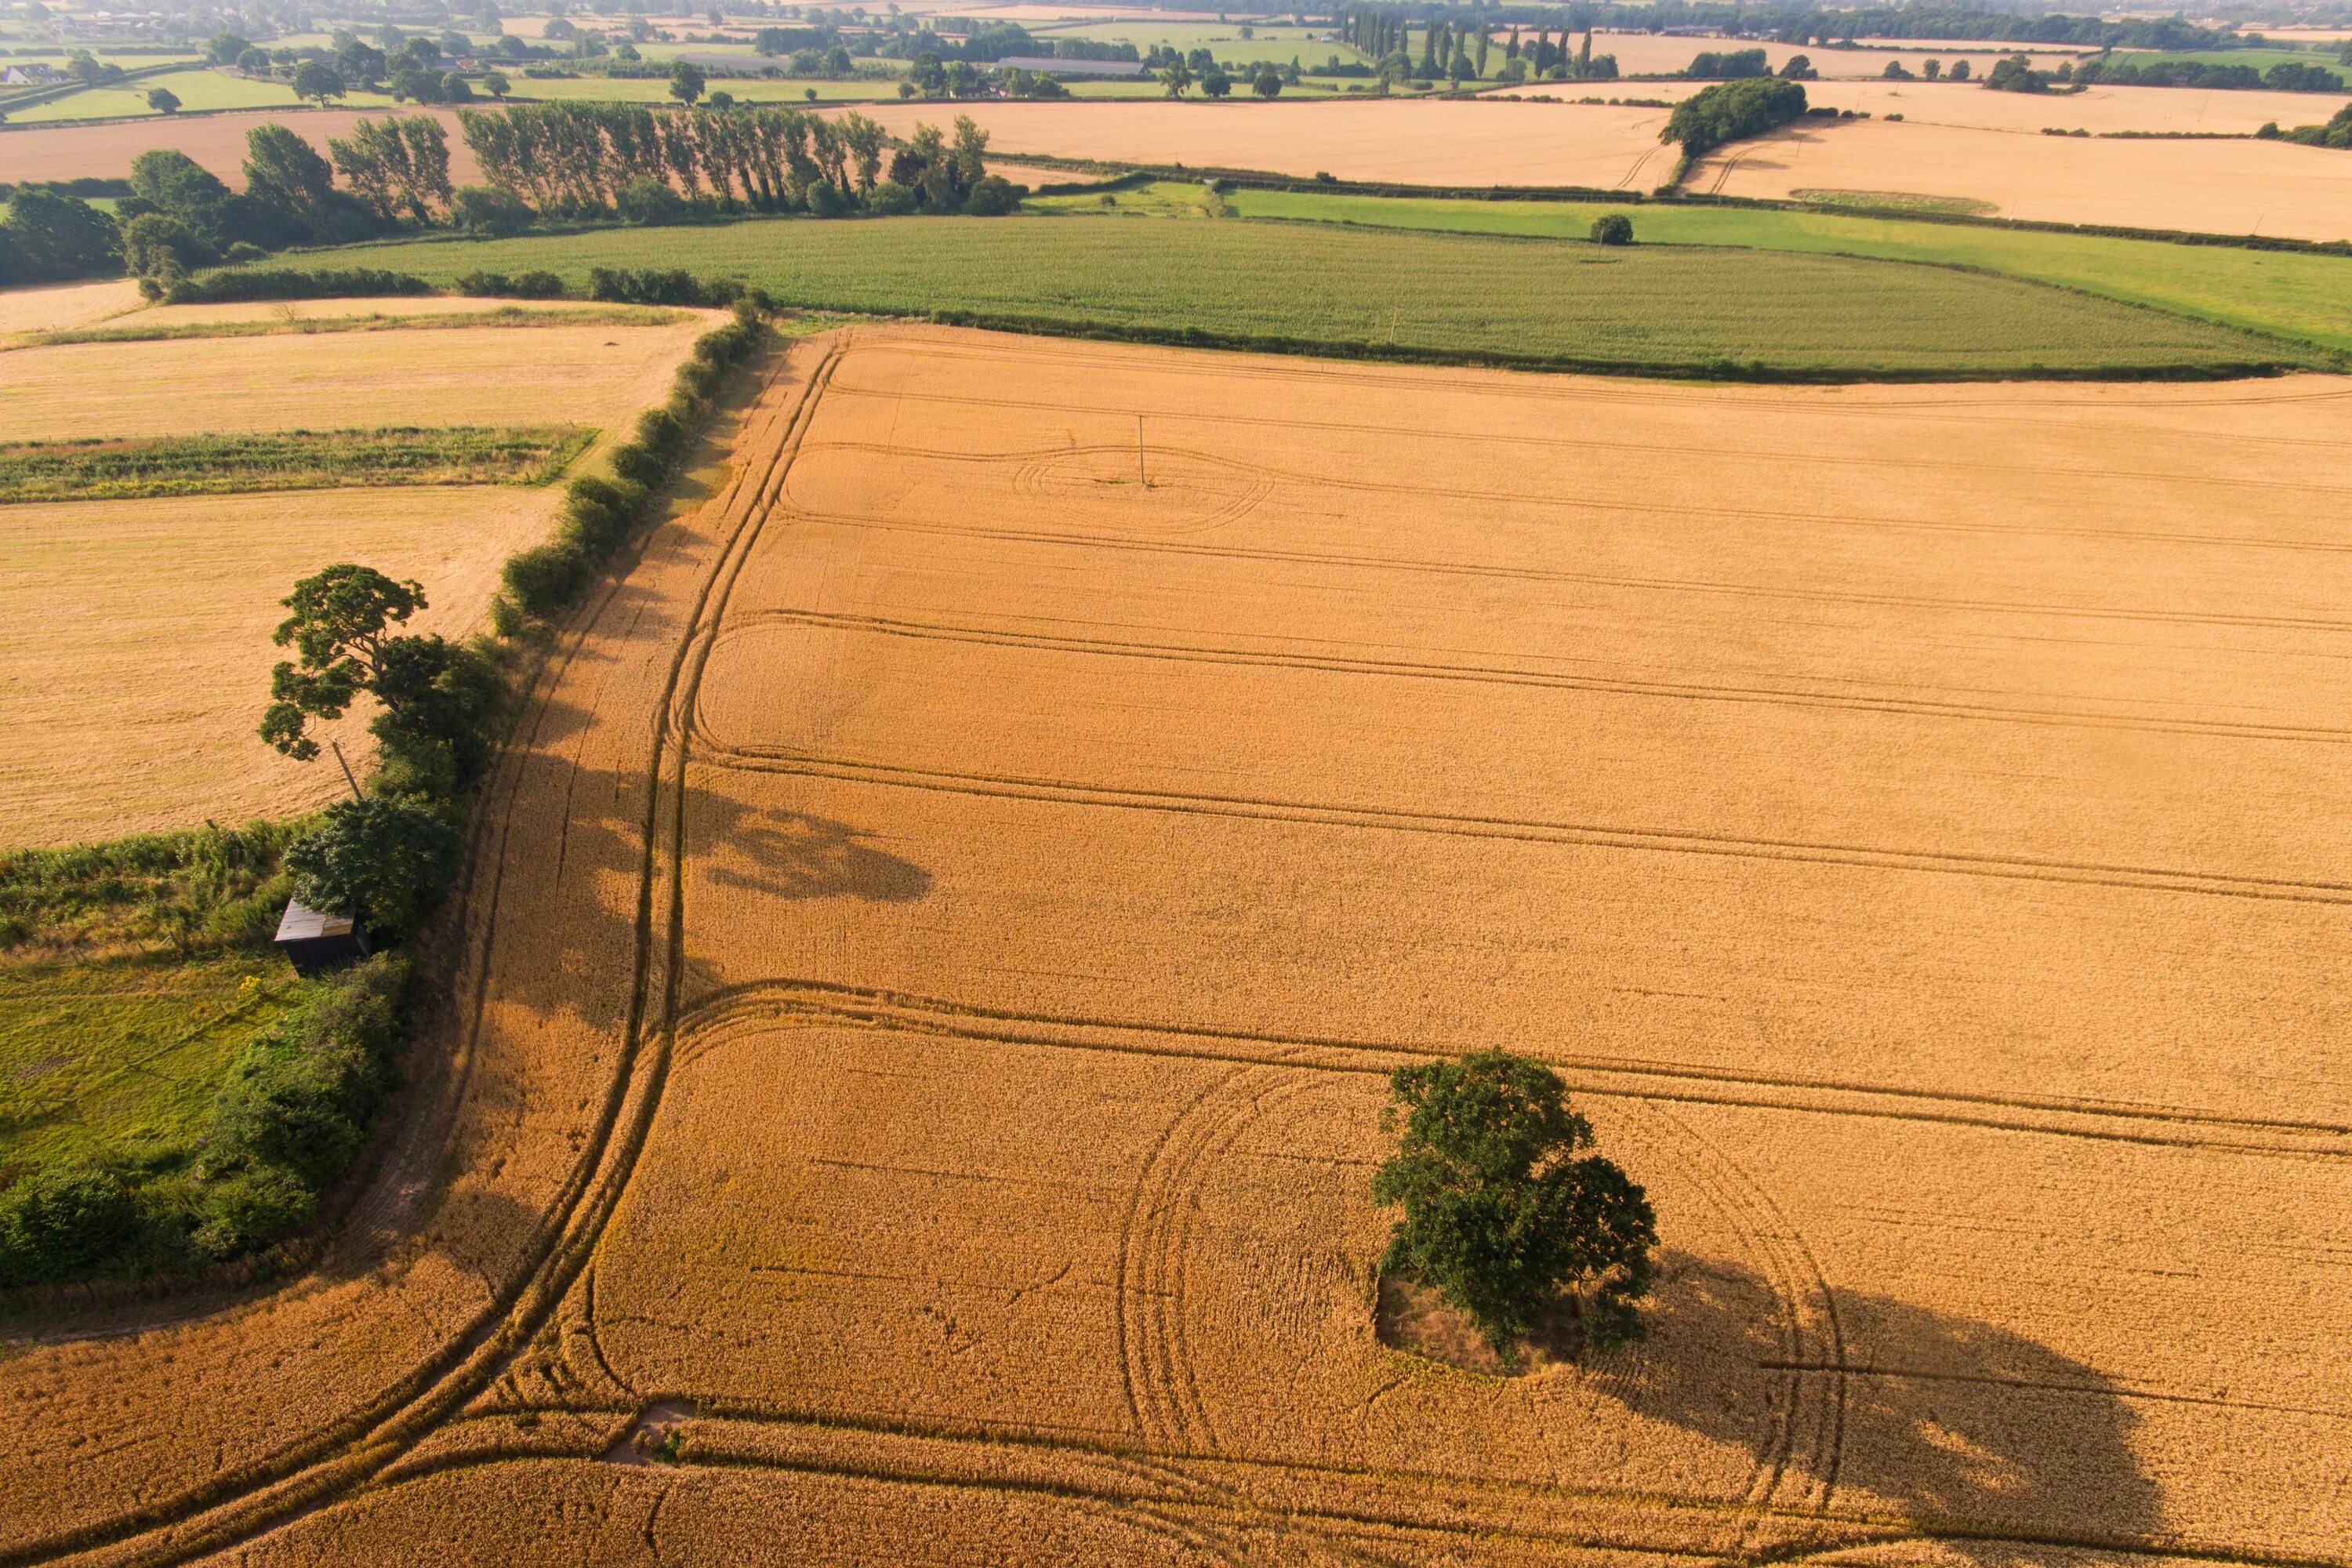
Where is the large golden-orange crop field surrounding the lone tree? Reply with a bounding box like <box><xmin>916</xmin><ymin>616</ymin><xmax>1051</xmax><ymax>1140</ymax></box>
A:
<box><xmin>0</xmin><ymin>329</ymin><xmax>2352</xmax><ymax>1566</ymax></box>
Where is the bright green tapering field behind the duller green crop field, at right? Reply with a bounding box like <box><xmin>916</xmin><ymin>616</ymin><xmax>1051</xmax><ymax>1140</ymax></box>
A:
<box><xmin>1223</xmin><ymin>186</ymin><xmax>2352</xmax><ymax>353</ymax></box>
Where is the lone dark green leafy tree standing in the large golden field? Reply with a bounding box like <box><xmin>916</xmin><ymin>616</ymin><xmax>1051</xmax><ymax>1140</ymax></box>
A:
<box><xmin>1371</xmin><ymin>1051</ymin><xmax>1658</xmax><ymax>1361</ymax></box>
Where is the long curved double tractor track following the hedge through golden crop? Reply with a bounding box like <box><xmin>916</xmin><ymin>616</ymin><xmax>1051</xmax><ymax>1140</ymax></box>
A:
<box><xmin>0</xmin><ymin>339</ymin><xmax>840</xmax><ymax>1568</ymax></box>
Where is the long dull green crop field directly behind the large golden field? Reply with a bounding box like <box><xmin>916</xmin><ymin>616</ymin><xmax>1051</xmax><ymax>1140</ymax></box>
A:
<box><xmin>252</xmin><ymin>216</ymin><xmax>2319</xmax><ymax>376</ymax></box>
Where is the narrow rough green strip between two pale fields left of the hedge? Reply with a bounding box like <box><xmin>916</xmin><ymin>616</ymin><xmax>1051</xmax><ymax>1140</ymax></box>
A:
<box><xmin>0</xmin><ymin>426</ymin><xmax>595</xmax><ymax>503</ymax></box>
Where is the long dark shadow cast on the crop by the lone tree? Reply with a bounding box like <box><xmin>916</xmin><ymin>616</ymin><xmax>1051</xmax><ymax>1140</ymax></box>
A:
<box><xmin>1590</xmin><ymin>1253</ymin><xmax>2164</xmax><ymax>1559</ymax></box>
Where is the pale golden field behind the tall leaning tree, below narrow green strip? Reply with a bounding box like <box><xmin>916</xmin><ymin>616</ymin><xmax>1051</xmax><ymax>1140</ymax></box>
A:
<box><xmin>0</xmin><ymin>487</ymin><xmax>553</xmax><ymax>846</ymax></box>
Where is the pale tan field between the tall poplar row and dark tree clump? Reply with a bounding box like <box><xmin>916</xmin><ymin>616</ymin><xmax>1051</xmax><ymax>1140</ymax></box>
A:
<box><xmin>837</xmin><ymin>97</ymin><xmax>1675</xmax><ymax>191</ymax></box>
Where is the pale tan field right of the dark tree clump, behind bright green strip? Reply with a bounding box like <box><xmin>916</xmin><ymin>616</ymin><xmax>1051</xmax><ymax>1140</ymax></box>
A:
<box><xmin>1686</xmin><ymin>118</ymin><xmax>2352</xmax><ymax>240</ymax></box>
